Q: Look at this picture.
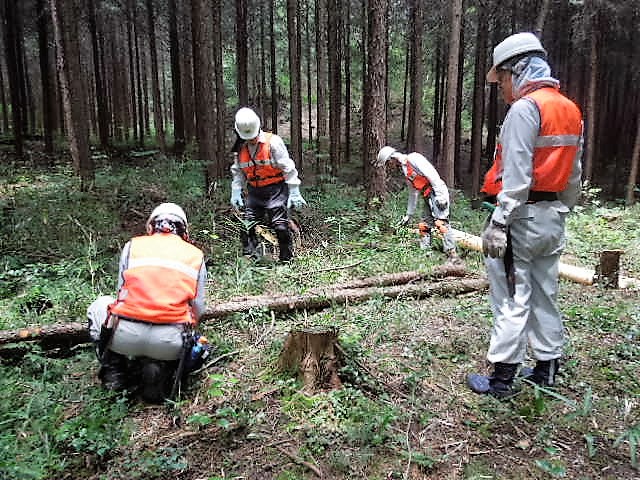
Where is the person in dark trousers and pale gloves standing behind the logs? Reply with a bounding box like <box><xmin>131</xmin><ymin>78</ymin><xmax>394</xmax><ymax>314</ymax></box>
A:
<box><xmin>231</xmin><ymin>107</ymin><xmax>307</xmax><ymax>262</ymax></box>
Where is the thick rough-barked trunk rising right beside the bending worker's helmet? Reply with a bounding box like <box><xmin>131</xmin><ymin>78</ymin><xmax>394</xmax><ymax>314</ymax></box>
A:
<box><xmin>362</xmin><ymin>0</ymin><xmax>388</xmax><ymax>202</ymax></box>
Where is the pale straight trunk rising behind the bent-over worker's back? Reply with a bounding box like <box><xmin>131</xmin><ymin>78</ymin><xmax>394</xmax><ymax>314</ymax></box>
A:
<box><xmin>442</xmin><ymin>0</ymin><xmax>462</xmax><ymax>188</ymax></box>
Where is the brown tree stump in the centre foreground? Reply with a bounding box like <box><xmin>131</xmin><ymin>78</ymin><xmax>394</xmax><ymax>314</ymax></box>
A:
<box><xmin>279</xmin><ymin>328</ymin><xmax>342</xmax><ymax>392</ymax></box>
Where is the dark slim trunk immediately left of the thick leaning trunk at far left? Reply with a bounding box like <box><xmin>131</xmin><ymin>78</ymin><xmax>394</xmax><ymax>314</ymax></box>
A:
<box><xmin>36</xmin><ymin>0</ymin><xmax>53</xmax><ymax>155</ymax></box>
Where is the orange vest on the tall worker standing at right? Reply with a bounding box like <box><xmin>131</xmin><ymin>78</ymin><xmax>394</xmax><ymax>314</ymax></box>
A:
<box><xmin>481</xmin><ymin>87</ymin><xmax>582</xmax><ymax>195</ymax></box>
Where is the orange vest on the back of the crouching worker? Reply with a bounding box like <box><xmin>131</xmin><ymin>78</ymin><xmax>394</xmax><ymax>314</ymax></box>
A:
<box><xmin>109</xmin><ymin>233</ymin><xmax>204</xmax><ymax>324</ymax></box>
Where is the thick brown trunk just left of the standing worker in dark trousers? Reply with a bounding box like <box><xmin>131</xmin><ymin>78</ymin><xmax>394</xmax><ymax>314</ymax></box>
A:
<box><xmin>191</xmin><ymin>0</ymin><xmax>217</xmax><ymax>188</ymax></box>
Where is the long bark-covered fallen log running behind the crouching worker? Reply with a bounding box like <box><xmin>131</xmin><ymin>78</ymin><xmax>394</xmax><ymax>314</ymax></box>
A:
<box><xmin>0</xmin><ymin>275</ymin><xmax>488</xmax><ymax>348</ymax></box>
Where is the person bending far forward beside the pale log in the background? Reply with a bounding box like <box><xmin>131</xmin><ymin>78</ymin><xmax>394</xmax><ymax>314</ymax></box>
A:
<box><xmin>377</xmin><ymin>146</ymin><xmax>464</xmax><ymax>268</ymax></box>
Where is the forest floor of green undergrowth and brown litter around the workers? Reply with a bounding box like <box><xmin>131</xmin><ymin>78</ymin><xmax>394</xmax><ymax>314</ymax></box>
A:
<box><xmin>0</xmin><ymin>147</ymin><xmax>640</xmax><ymax>480</ymax></box>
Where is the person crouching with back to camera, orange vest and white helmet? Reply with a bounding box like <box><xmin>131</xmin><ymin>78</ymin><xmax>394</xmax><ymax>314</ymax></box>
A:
<box><xmin>87</xmin><ymin>203</ymin><xmax>207</xmax><ymax>403</ymax></box>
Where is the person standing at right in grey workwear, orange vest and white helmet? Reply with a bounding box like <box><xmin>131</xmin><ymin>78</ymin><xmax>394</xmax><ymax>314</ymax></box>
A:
<box><xmin>467</xmin><ymin>33</ymin><xmax>583</xmax><ymax>398</ymax></box>
